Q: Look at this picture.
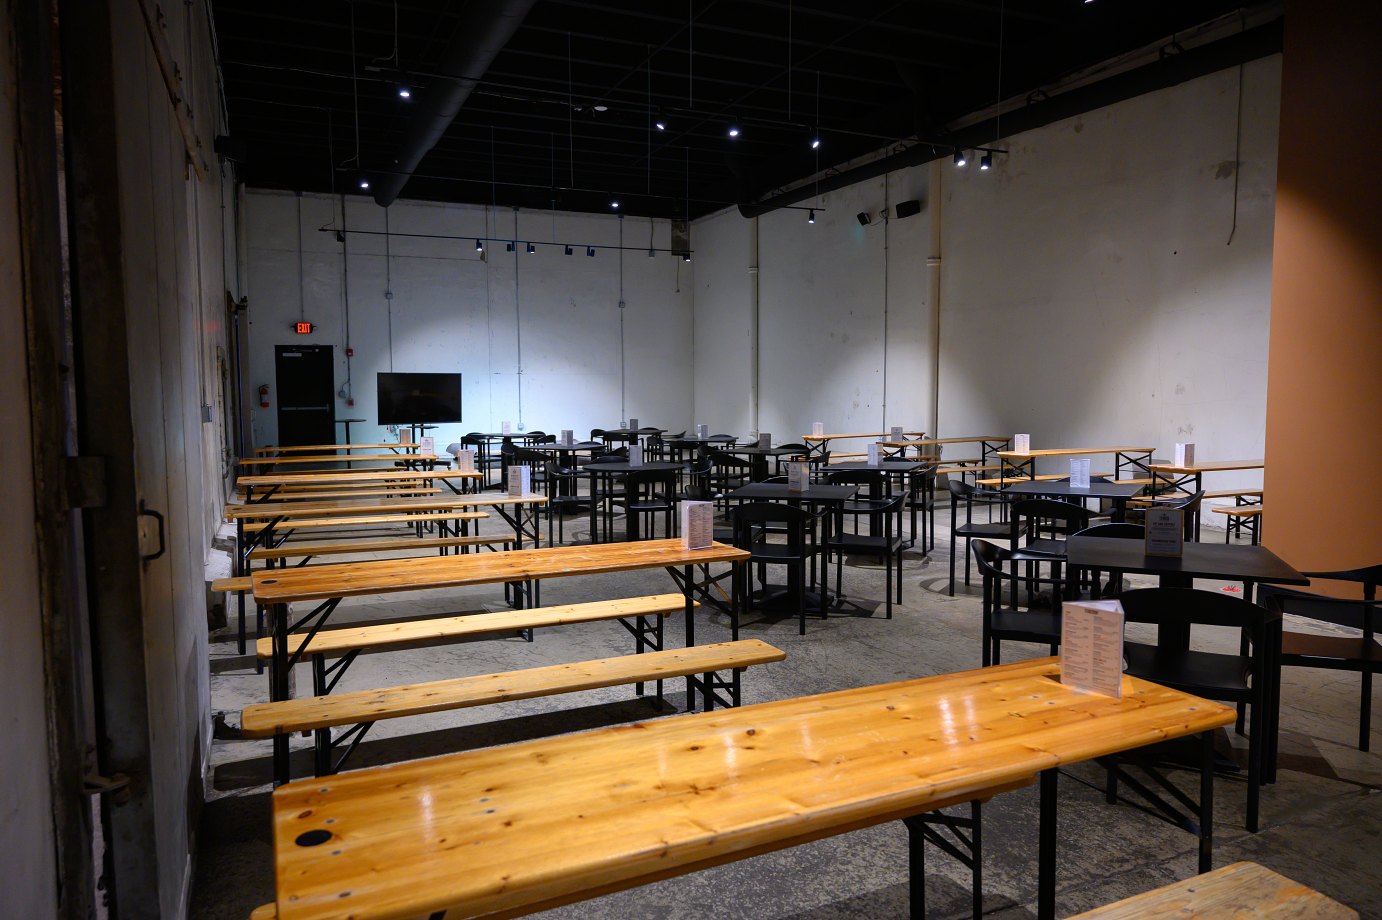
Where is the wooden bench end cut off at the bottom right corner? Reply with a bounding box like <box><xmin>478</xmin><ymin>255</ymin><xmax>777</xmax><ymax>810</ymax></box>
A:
<box><xmin>1070</xmin><ymin>862</ymin><xmax>1359</xmax><ymax>920</ymax></box>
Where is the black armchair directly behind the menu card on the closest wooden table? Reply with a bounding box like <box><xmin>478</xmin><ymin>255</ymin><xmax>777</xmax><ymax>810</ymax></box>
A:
<box><xmin>1107</xmin><ymin>587</ymin><xmax>1281</xmax><ymax>833</ymax></box>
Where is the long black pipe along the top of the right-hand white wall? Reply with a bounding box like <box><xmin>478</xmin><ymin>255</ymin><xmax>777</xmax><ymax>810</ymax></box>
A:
<box><xmin>739</xmin><ymin>18</ymin><xmax>1282</xmax><ymax>217</ymax></box>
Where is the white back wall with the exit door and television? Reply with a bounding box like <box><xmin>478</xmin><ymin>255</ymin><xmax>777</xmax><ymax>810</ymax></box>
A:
<box><xmin>246</xmin><ymin>191</ymin><xmax>691</xmax><ymax>445</ymax></box>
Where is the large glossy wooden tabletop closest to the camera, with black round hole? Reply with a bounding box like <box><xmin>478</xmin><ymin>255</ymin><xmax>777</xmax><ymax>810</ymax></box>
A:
<box><xmin>266</xmin><ymin>659</ymin><xmax>1234</xmax><ymax>920</ymax></box>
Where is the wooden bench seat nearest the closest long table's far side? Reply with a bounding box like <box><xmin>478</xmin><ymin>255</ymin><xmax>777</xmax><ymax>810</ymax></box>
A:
<box><xmin>240</xmin><ymin>640</ymin><xmax>786</xmax><ymax>738</ymax></box>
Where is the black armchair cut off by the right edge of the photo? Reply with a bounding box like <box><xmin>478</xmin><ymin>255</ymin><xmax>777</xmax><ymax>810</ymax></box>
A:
<box><xmin>1258</xmin><ymin>580</ymin><xmax>1382</xmax><ymax>751</ymax></box>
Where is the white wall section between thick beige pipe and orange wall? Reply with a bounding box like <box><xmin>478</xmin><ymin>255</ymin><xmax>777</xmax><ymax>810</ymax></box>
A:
<box><xmin>941</xmin><ymin>57</ymin><xmax>1281</xmax><ymax>489</ymax></box>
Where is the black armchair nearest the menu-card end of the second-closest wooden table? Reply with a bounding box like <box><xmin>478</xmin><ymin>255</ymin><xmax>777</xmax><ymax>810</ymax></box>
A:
<box><xmin>730</xmin><ymin>501</ymin><xmax>825</xmax><ymax>635</ymax></box>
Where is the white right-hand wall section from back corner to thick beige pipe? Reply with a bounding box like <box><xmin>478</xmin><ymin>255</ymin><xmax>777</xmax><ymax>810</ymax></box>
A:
<box><xmin>694</xmin><ymin>170</ymin><xmax>931</xmax><ymax>441</ymax></box>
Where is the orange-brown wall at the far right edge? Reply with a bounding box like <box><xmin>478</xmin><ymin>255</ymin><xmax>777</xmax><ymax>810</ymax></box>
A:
<box><xmin>1263</xmin><ymin>0</ymin><xmax>1382</xmax><ymax>569</ymax></box>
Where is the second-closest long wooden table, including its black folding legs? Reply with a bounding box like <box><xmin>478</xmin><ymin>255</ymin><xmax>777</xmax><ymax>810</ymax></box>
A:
<box><xmin>252</xmin><ymin>539</ymin><xmax>749</xmax><ymax>776</ymax></box>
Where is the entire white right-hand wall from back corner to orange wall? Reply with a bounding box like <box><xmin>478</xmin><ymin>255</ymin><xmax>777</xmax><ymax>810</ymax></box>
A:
<box><xmin>694</xmin><ymin>57</ymin><xmax>1281</xmax><ymax>488</ymax></box>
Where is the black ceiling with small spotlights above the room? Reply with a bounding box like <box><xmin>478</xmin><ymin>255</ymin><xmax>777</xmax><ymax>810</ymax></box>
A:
<box><xmin>213</xmin><ymin>0</ymin><xmax>1242</xmax><ymax>217</ymax></box>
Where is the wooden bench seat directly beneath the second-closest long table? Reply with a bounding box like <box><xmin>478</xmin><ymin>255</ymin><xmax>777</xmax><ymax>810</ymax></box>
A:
<box><xmin>254</xmin><ymin>593</ymin><xmax>699</xmax><ymax>660</ymax></box>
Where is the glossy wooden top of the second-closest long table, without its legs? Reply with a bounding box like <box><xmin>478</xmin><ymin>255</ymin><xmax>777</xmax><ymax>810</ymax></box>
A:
<box><xmin>253</xmin><ymin>539</ymin><xmax>749</xmax><ymax>604</ymax></box>
